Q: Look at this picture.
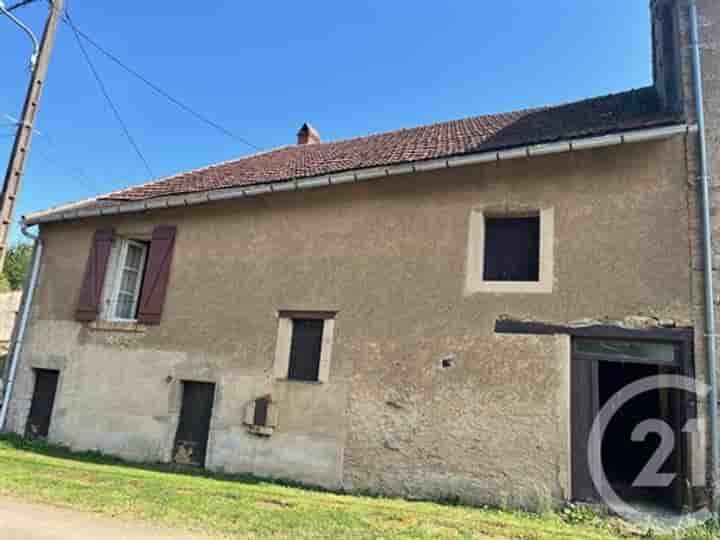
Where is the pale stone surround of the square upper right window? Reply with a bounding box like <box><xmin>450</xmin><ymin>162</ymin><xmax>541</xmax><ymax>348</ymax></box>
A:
<box><xmin>465</xmin><ymin>208</ymin><xmax>555</xmax><ymax>295</ymax></box>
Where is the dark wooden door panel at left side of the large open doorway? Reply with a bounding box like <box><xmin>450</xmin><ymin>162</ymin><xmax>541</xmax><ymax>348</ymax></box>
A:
<box><xmin>571</xmin><ymin>360</ymin><xmax>600</xmax><ymax>501</ymax></box>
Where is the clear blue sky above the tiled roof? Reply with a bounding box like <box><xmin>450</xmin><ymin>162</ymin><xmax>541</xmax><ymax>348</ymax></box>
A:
<box><xmin>0</xmin><ymin>0</ymin><xmax>651</xmax><ymax>238</ymax></box>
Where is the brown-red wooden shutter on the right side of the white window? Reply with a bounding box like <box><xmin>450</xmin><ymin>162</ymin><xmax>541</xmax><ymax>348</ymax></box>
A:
<box><xmin>138</xmin><ymin>225</ymin><xmax>177</xmax><ymax>324</ymax></box>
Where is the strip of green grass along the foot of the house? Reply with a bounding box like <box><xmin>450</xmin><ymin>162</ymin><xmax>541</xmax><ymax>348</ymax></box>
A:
<box><xmin>0</xmin><ymin>436</ymin><xmax>717</xmax><ymax>540</ymax></box>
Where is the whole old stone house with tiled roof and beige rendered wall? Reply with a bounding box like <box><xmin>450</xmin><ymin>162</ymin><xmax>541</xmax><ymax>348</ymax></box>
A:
<box><xmin>5</xmin><ymin>0</ymin><xmax>720</xmax><ymax>507</ymax></box>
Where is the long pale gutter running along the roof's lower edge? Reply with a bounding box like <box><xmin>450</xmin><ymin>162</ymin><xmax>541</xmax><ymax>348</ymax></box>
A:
<box><xmin>23</xmin><ymin>124</ymin><xmax>697</xmax><ymax>225</ymax></box>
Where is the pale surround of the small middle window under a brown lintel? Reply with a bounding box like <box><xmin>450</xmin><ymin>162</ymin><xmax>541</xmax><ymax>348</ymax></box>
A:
<box><xmin>273</xmin><ymin>311</ymin><xmax>335</xmax><ymax>384</ymax></box>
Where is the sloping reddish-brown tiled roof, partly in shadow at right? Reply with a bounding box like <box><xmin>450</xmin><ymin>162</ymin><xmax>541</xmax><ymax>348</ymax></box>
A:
<box><xmin>26</xmin><ymin>87</ymin><xmax>682</xmax><ymax>219</ymax></box>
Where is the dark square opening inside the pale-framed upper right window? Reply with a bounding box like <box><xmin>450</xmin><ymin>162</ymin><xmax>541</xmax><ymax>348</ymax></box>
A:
<box><xmin>483</xmin><ymin>216</ymin><xmax>540</xmax><ymax>282</ymax></box>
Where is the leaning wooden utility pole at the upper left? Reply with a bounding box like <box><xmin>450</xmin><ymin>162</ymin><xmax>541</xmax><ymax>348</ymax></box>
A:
<box><xmin>0</xmin><ymin>0</ymin><xmax>64</xmax><ymax>269</ymax></box>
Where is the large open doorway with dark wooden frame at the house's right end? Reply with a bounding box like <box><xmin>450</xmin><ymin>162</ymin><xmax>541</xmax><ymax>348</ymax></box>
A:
<box><xmin>571</xmin><ymin>339</ymin><xmax>691</xmax><ymax>510</ymax></box>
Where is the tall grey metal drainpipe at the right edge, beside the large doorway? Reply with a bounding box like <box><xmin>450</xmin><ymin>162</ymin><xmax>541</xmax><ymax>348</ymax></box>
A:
<box><xmin>690</xmin><ymin>0</ymin><xmax>720</xmax><ymax>512</ymax></box>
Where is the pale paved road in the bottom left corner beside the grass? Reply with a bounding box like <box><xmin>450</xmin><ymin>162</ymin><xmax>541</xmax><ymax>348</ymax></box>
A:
<box><xmin>0</xmin><ymin>497</ymin><xmax>208</xmax><ymax>540</ymax></box>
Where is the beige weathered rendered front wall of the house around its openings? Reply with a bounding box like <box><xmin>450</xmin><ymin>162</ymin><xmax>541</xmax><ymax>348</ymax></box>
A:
<box><xmin>4</xmin><ymin>137</ymin><xmax>695</xmax><ymax>506</ymax></box>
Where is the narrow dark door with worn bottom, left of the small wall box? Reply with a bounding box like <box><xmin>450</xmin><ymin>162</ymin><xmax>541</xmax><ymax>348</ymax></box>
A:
<box><xmin>173</xmin><ymin>381</ymin><xmax>215</xmax><ymax>467</ymax></box>
